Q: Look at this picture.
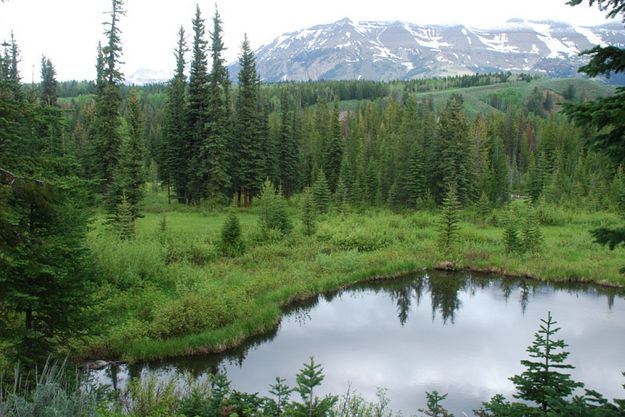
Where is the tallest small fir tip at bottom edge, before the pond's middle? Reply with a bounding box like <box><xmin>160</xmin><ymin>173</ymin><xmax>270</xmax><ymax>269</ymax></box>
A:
<box><xmin>291</xmin><ymin>357</ymin><xmax>338</xmax><ymax>417</ymax></box>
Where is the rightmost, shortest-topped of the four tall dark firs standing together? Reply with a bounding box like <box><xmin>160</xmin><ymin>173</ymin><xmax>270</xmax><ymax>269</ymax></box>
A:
<box><xmin>237</xmin><ymin>35</ymin><xmax>264</xmax><ymax>207</ymax></box>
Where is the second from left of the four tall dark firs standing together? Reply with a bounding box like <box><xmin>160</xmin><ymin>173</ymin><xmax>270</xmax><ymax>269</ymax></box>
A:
<box><xmin>184</xmin><ymin>5</ymin><xmax>210</xmax><ymax>203</ymax></box>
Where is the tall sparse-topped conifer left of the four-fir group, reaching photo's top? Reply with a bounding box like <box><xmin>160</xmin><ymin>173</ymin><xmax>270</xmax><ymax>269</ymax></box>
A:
<box><xmin>91</xmin><ymin>0</ymin><xmax>125</xmax><ymax>191</ymax></box>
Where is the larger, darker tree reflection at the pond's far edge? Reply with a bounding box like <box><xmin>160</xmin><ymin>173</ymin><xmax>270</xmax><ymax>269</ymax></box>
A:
<box><xmin>428</xmin><ymin>274</ymin><xmax>469</xmax><ymax>324</ymax></box>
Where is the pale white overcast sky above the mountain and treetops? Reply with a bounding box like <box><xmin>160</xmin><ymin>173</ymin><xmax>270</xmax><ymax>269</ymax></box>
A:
<box><xmin>0</xmin><ymin>0</ymin><xmax>606</xmax><ymax>82</ymax></box>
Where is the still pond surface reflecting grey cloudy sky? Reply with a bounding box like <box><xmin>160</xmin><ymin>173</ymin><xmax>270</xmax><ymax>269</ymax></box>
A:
<box><xmin>92</xmin><ymin>275</ymin><xmax>625</xmax><ymax>416</ymax></box>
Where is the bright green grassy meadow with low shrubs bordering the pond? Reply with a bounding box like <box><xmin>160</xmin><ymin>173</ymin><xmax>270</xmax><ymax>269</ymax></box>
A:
<box><xmin>83</xmin><ymin>193</ymin><xmax>625</xmax><ymax>361</ymax></box>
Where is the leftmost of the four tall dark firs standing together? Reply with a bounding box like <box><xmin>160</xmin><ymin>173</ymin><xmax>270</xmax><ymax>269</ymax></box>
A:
<box><xmin>159</xmin><ymin>27</ymin><xmax>189</xmax><ymax>203</ymax></box>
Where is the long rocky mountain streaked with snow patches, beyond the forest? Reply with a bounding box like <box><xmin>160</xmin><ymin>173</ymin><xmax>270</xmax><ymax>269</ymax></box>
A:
<box><xmin>230</xmin><ymin>19</ymin><xmax>625</xmax><ymax>82</ymax></box>
